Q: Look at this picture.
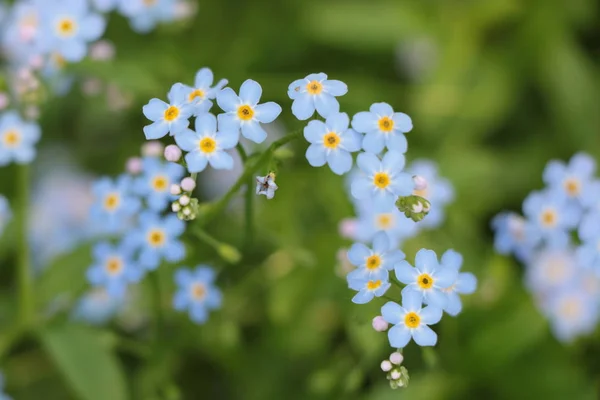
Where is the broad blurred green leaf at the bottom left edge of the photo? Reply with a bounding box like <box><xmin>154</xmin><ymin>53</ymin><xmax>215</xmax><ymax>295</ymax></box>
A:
<box><xmin>40</xmin><ymin>325</ymin><xmax>128</xmax><ymax>400</ymax></box>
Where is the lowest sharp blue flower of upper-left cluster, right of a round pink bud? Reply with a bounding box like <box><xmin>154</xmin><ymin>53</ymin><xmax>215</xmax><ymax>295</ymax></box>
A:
<box><xmin>175</xmin><ymin>113</ymin><xmax>239</xmax><ymax>173</ymax></box>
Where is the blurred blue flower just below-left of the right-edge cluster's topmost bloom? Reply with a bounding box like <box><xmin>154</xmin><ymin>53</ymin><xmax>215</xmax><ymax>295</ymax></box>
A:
<box><xmin>523</xmin><ymin>191</ymin><xmax>580</xmax><ymax>246</ymax></box>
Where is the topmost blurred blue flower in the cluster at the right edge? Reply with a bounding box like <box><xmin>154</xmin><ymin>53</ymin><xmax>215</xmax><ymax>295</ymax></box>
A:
<box><xmin>543</xmin><ymin>153</ymin><xmax>596</xmax><ymax>205</ymax></box>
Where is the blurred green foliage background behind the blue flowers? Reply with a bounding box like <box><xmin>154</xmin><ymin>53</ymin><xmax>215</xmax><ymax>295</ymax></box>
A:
<box><xmin>0</xmin><ymin>0</ymin><xmax>600</xmax><ymax>400</ymax></box>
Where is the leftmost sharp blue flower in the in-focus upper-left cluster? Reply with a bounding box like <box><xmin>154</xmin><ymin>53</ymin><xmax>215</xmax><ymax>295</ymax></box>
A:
<box><xmin>142</xmin><ymin>83</ymin><xmax>194</xmax><ymax>140</ymax></box>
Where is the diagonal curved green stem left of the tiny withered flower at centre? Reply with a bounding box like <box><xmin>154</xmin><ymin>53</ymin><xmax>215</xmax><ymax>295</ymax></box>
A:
<box><xmin>197</xmin><ymin>130</ymin><xmax>302</xmax><ymax>226</ymax></box>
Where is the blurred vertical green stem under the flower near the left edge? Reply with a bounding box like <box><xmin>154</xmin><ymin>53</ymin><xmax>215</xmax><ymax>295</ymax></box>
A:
<box><xmin>15</xmin><ymin>165</ymin><xmax>33</xmax><ymax>326</ymax></box>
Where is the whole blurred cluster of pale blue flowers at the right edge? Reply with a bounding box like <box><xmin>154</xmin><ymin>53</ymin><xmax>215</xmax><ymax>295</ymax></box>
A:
<box><xmin>492</xmin><ymin>153</ymin><xmax>600</xmax><ymax>342</ymax></box>
